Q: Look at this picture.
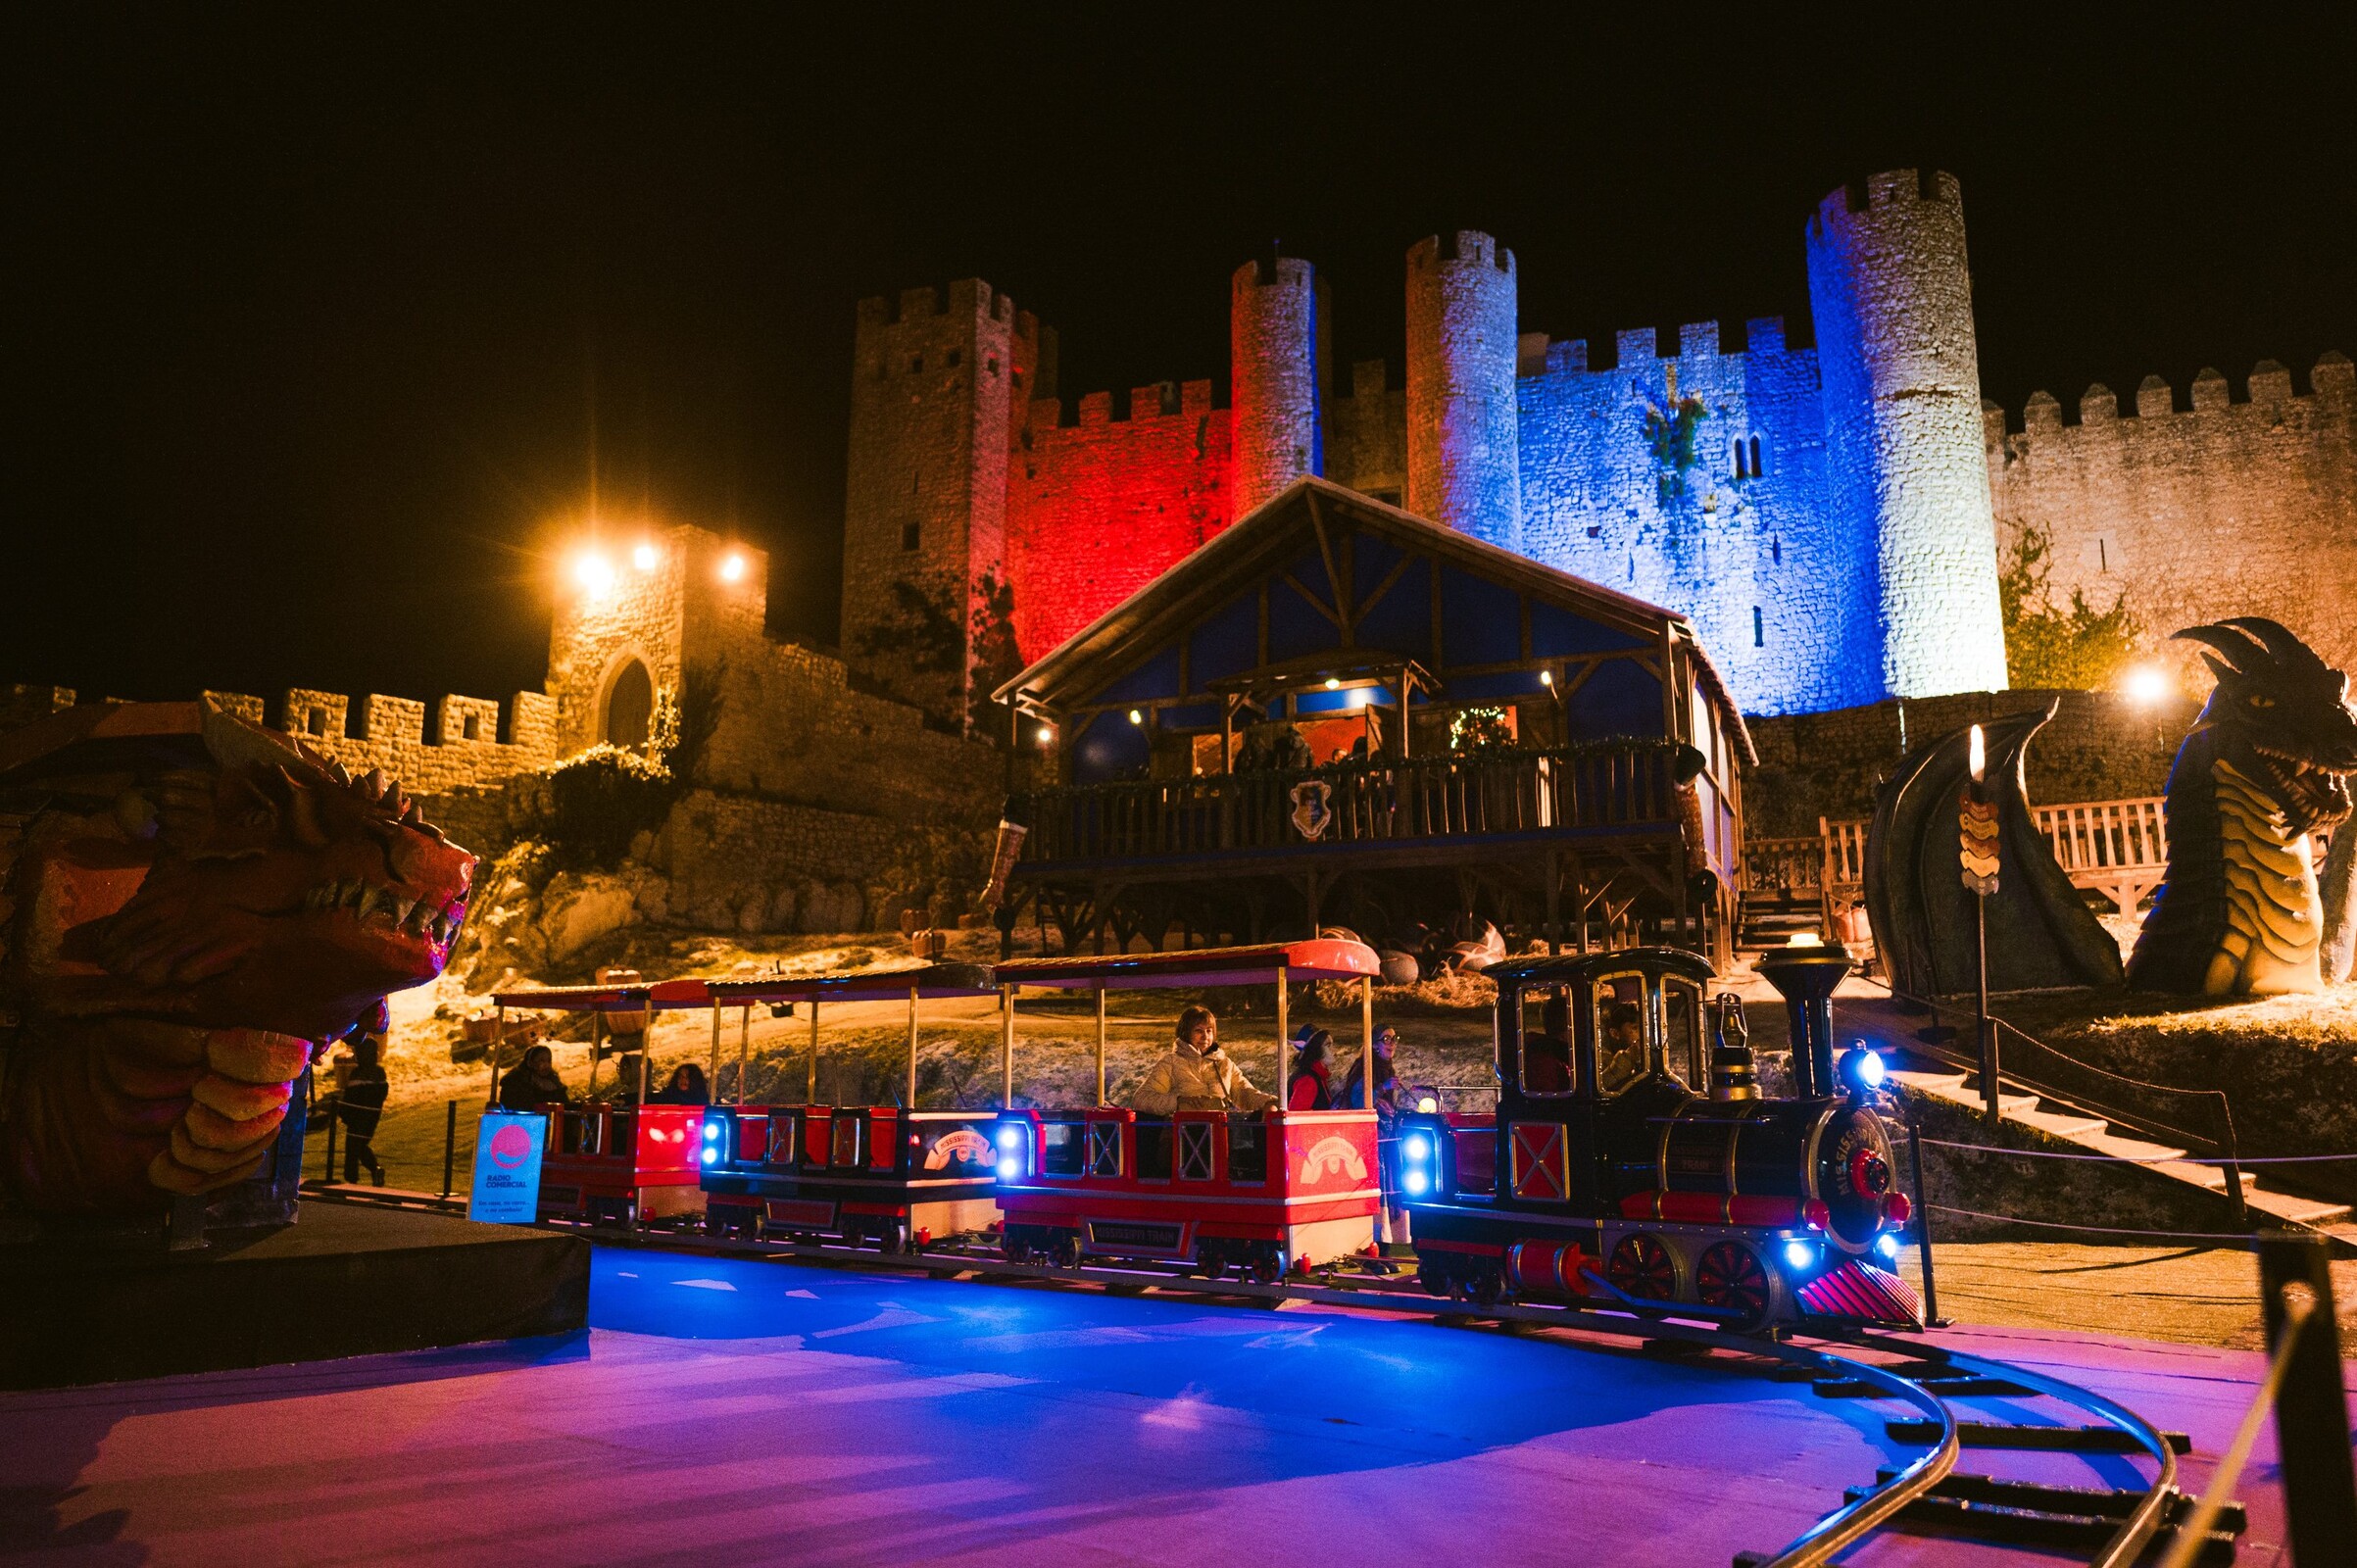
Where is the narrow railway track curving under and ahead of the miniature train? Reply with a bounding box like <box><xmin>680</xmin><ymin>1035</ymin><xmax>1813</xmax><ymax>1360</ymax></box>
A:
<box><xmin>320</xmin><ymin>1191</ymin><xmax>2244</xmax><ymax>1568</ymax></box>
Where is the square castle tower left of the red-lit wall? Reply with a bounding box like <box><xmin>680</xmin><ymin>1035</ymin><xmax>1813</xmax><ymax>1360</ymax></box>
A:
<box><xmin>842</xmin><ymin>278</ymin><xmax>1054</xmax><ymax>726</ymax></box>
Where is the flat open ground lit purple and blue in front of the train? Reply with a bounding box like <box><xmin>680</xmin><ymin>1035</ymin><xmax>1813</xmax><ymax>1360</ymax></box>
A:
<box><xmin>0</xmin><ymin>1250</ymin><xmax>2319</xmax><ymax>1568</ymax></box>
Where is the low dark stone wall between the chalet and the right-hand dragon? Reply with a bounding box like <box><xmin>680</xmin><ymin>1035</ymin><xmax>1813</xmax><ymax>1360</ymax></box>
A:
<box><xmin>1744</xmin><ymin>691</ymin><xmax>2199</xmax><ymax>840</ymax></box>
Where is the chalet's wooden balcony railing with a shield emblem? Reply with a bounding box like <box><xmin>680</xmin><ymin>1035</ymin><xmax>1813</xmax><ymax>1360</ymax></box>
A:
<box><xmin>1023</xmin><ymin>740</ymin><xmax>1678</xmax><ymax>865</ymax></box>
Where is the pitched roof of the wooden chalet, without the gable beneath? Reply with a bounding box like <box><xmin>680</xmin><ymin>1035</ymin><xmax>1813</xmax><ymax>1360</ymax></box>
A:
<box><xmin>993</xmin><ymin>476</ymin><xmax>1756</xmax><ymax>761</ymax></box>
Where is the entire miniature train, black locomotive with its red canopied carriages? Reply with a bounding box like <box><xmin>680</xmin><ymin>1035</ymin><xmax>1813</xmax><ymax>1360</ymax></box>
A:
<box><xmin>487</xmin><ymin>939</ymin><xmax>1921</xmax><ymax>1330</ymax></box>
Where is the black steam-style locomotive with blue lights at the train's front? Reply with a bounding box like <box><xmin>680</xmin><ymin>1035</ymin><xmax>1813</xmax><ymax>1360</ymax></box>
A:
<box><xmin>1400</xmin><ymin>948</ymin><xmax>1921</xmax><ymax>1328</ymax></box>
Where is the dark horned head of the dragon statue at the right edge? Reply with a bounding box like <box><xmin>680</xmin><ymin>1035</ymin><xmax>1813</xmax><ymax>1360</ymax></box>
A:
<box><xmin>2178</xmin><ymin>615</ymin><xmax>2357</xmax><ymax>832</ymax></box>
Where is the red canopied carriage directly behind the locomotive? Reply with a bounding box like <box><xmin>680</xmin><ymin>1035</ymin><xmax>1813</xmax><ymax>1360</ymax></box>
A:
<box><xmin>995</xmin><ymin>941</ymin><xmax>1381</xmax><ymax>1280</ymax></box>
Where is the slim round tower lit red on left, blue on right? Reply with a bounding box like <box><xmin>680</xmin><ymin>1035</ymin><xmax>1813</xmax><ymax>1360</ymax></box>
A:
<box><xmin>1228</xmin><ymin>257</ymin><xmax>1327</xmax><ymax>518</ymax></box>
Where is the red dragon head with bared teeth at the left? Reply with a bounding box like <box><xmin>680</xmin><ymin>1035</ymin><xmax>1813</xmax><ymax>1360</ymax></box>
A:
<box><xmin>22</xmin><ymin>710</ymin><xmax>476</xmax><ymax>1040</ymax></box>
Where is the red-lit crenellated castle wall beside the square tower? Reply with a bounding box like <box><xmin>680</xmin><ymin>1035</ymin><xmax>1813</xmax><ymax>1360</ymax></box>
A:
<box><xmin>1007</xmin><ymin>382</ymin><xmax>1235</xmax><ymax>662</ymax></box>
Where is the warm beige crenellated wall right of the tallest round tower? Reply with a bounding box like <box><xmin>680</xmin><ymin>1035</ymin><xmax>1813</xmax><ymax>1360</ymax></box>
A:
<box><xmin>1985</xmin><ymin>354</ymin><xmax>2357</xmax><ymax>669</ymax></box>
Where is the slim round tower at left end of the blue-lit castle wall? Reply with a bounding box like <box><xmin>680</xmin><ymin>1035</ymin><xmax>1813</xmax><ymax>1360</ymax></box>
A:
<box><xmin>1407</xmin><ymin>231</ymin><xmax>1523</xmax><ymax>550</ymax></box>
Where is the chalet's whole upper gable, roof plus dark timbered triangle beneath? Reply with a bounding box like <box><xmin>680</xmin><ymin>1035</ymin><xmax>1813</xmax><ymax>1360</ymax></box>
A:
<box><xmin>995</xmin><ymin>478</ymin><xmax>1756</xmax><ymax>771</ymax></box>
